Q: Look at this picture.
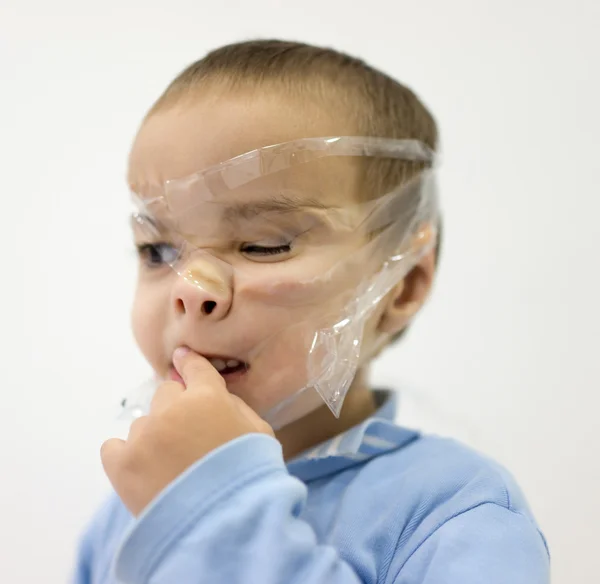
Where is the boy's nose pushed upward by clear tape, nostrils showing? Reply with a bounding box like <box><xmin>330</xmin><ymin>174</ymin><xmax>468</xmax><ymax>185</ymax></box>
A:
<box><xmin>173</xmin><ymin>256</ymin><xmax>233</xmax><ymax>321</ymax></box>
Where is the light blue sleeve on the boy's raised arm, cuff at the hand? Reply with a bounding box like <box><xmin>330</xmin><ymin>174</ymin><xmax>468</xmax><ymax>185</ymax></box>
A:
<box><xmin>113</xmin><ymin>434</ymin><xmax>370</xmax><ymax>584</ymax></box>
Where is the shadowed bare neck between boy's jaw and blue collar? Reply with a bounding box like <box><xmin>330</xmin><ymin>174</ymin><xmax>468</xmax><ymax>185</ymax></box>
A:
<box><xmin>275</xmin><ymin>372</ymin><xmax>377</xmax><ymax>460</ymax></box>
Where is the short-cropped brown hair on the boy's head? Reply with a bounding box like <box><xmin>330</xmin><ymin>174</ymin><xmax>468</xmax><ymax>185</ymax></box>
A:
<box><xmin>148</xmin><ymin>40</ymin><xmax>438</xmax><ymax>193</ymax></box>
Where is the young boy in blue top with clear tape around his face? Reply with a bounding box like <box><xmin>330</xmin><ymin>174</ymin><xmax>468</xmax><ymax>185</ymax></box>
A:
<box><xmin>75</xmin><ymin>41</ymin><xmax>549</xmax><ymax>584</ymax></box>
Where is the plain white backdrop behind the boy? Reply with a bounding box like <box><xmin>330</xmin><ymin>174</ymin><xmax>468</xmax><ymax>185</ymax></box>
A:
<box><xmin>0</xmin><ymin>0</ymin><xmax>600</xmax><ymax>584</ymax></box>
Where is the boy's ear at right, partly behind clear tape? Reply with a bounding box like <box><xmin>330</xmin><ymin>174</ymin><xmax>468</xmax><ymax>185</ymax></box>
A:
<box><xmin>377</xmin><ymin>250</ymin><xmax>436</xmax><ymax>336</ymax></box>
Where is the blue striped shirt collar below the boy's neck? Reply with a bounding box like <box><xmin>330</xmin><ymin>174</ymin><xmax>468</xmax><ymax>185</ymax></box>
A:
<box><xmin>287</xmin><ymin>391</ymin><xmax>419</xmax><ymax>482</ymax></box>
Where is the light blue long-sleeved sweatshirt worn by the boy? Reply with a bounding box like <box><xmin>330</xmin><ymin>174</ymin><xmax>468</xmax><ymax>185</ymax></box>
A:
<box><xmin>73</xmin><ymin>392</ymin><xmax>550</xmax><ymax>584</ymax></box>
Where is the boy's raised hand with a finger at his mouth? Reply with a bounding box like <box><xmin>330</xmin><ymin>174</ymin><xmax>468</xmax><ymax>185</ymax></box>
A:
<box><xmin>101</xmin><ymin>349</ymin><xmax>274</xmax><ymax>515</ymax></box>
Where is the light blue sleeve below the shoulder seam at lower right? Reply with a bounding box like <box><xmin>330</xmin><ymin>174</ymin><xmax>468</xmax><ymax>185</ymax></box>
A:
<box><xmin>390</xmin><ymin>503</ymin><xmax>550</xmax><ymax>584</ymax></box>
